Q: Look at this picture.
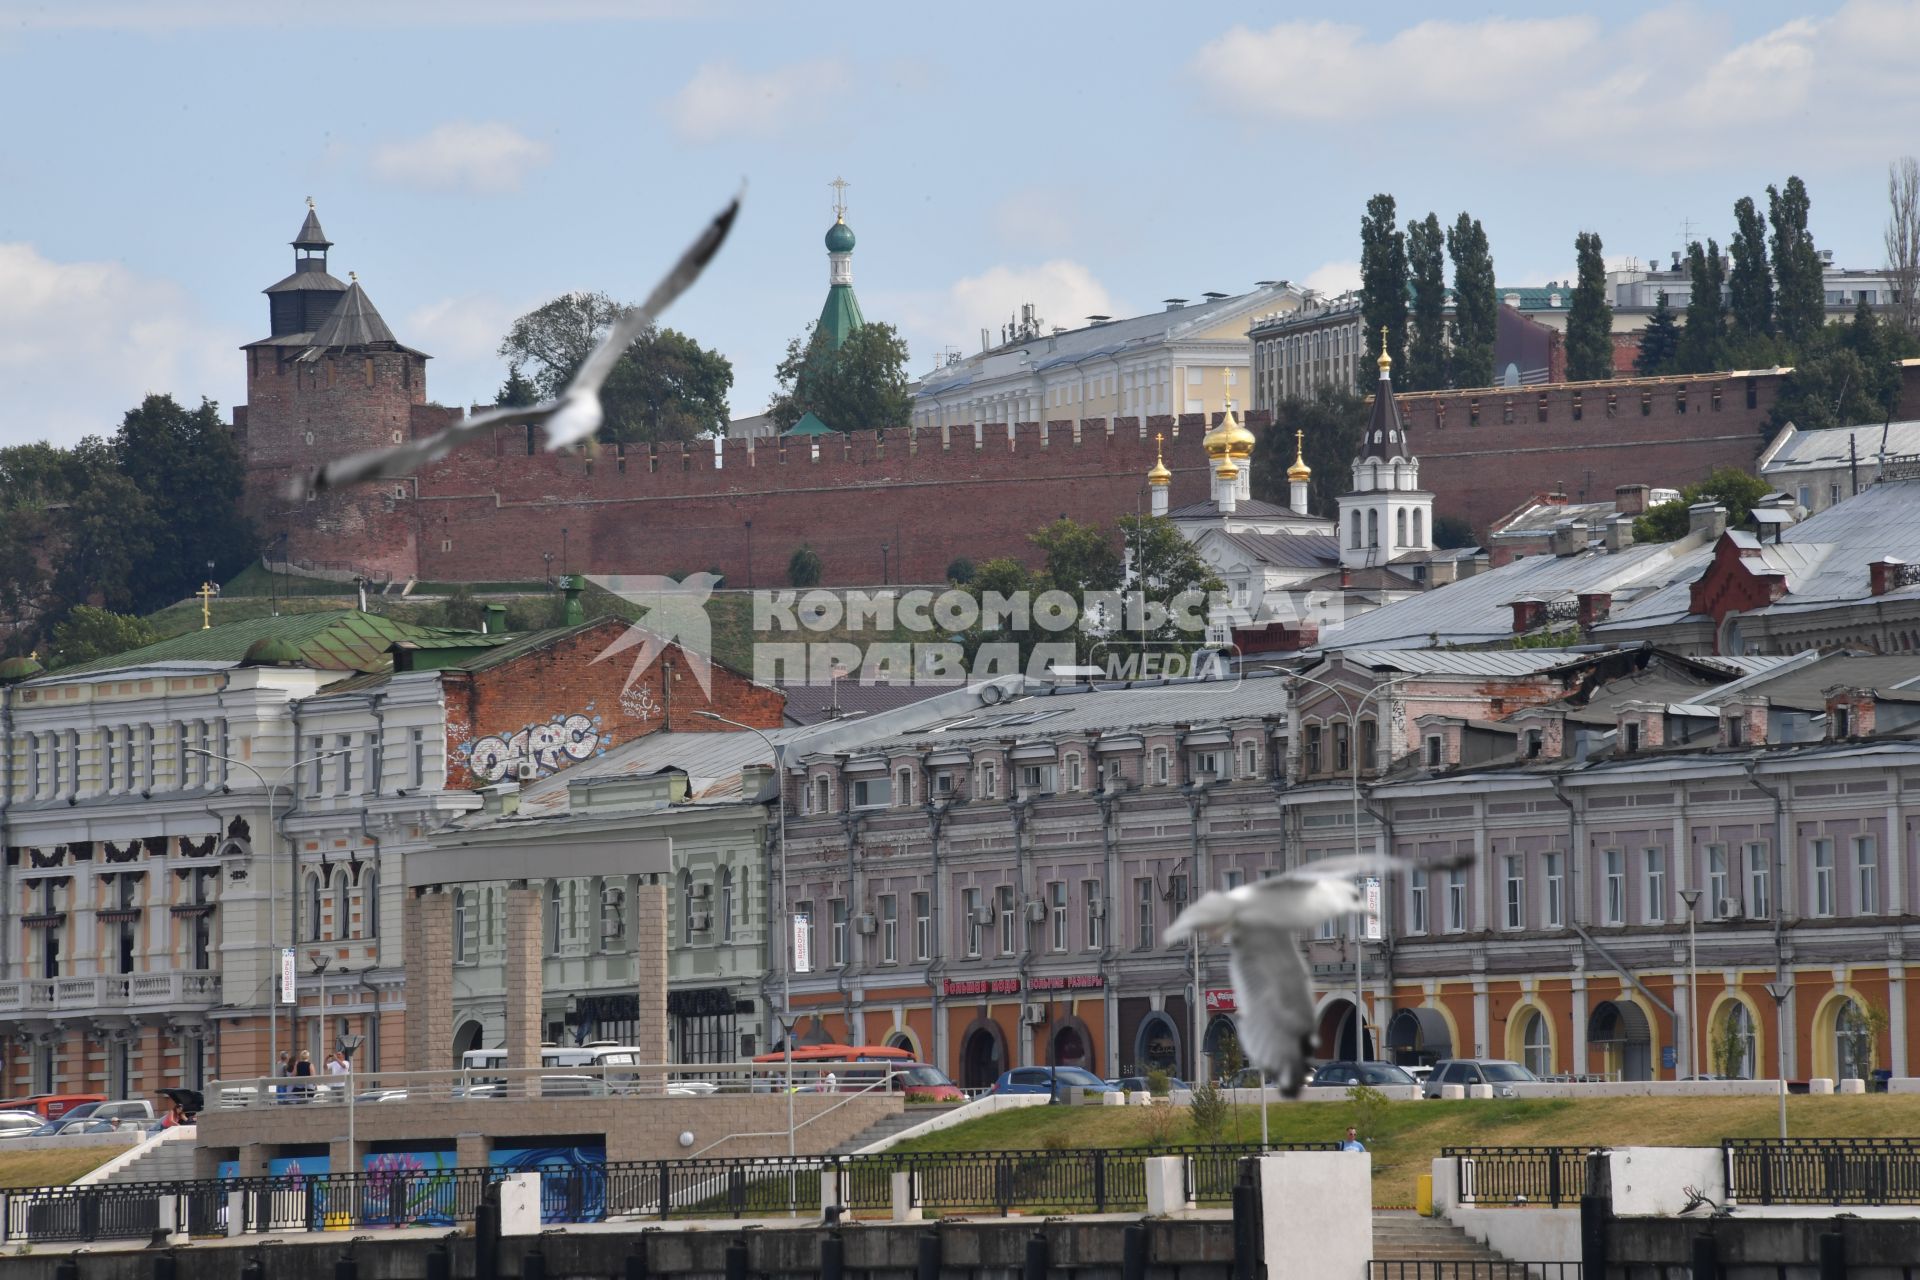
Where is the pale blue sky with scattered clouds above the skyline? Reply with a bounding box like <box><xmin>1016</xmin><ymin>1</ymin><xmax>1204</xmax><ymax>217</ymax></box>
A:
<box><xmin>0</xmin><ymin>0</ymin><xmax>1920</xmax><ymax>443</ymax></box>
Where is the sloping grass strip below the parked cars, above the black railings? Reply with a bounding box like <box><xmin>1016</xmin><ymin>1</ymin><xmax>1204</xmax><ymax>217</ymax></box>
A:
<box><xmin>891</xmin><ymin>1094</ymin><xmax>1920</xmax><ymax>1207</ymax></box>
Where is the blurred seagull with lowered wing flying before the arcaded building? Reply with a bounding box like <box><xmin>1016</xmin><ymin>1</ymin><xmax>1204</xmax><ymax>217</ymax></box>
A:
<box><xmin>1167</xmin><ymin>854</ymin><xmax>1471</xmax><ymax>1098</ymax></box>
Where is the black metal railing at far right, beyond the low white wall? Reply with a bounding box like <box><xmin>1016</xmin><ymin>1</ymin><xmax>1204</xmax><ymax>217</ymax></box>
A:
<box><xmin>1720</xmin><ymin>1138</ymin><xmax>1920</xmax><ymax>1205</ymax></box>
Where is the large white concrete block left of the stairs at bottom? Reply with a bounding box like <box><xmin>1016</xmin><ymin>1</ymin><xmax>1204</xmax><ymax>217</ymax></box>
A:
<box><xmin>1260</xmin><ymin>1151</ymin><xmax>1373</xmax><ymax>1280</ymax></box>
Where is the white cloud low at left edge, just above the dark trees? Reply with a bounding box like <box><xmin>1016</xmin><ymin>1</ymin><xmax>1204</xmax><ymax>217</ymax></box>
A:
<box><xmin>0</xmin><ymin>242</ymin><xmax>244</xmax><ymax>443</ymax></box>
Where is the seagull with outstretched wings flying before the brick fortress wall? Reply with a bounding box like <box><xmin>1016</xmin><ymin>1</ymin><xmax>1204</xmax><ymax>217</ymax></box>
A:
<box><xmin>288</xmin><ymin>196</ymin><xmax>739</xmax><ymax>499</ymax></box>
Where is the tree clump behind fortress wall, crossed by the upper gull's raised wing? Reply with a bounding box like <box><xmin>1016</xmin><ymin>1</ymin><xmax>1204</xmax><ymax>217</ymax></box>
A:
<box><xmin>499</xmin><ymin>294</ymin><xmax>733</xmax><ymax>441</ymax></box>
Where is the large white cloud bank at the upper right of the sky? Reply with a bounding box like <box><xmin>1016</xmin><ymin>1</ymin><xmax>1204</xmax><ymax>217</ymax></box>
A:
<box><xmin>1188</xmin><ymin>0</ymin><xmax>1920</xmax><ymax>169</ymax></box>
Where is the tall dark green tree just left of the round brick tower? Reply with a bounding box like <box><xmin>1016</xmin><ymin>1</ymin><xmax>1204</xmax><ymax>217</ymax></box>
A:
<box><xmin>111</xmin><ymin>395</ymin><xmax>255</xmax><ymax>612</ymax></box>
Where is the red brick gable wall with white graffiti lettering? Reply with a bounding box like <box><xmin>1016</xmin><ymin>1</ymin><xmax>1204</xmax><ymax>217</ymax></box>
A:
<box><xmin>445</xmin><ymin>618</ymin><xmax>783</xmax><ymax>787</ymax></box>
